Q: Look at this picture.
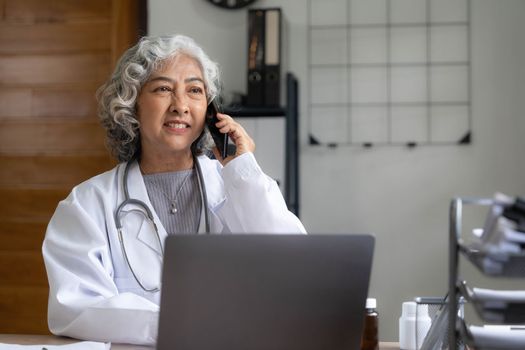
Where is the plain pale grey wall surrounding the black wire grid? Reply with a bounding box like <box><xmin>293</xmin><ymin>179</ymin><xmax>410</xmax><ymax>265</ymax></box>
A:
<box><xmin>149</xmin><ymin>0</ymin><xmax>525</xmax><ymax>340</ymax></box>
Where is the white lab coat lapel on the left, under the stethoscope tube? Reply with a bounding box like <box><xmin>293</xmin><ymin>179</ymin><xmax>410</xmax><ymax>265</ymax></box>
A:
<box><xmin>124</xmin><ymin>161</ymin><xmax>167</xmax><ymax>255</ymax></box>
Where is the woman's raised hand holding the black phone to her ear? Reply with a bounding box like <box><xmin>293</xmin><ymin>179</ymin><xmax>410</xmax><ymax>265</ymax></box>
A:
<box><xmin>213</xmin><ymin>113</ymin><xmax>255</xmax><ymax>165</ymax></box>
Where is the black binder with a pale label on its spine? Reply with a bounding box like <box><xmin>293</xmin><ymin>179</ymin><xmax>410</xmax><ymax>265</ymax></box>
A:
<box><xmin>264</xmin><ymin>8</ymin><xmax>282</xmax><ymax>107</ymax></box>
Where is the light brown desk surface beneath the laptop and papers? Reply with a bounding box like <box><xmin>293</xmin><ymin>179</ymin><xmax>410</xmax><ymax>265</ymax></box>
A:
<box><xmin>0</xmin><ymin>334</ymin><xmax>399</xmax><ymax>350</ymax></box>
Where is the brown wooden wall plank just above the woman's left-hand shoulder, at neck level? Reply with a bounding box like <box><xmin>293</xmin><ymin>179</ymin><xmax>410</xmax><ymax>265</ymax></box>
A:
<box><xmin>0</xmin><ymin>153</ymin><xmax>116</xmax><ymax>187</ymax></box>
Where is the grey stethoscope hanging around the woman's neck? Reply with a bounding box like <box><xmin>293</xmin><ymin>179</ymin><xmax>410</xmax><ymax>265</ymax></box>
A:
<box><xmin>115</xmin><ymin>156</ymin><xmax>210</xmax><ymax>293</ymax></box>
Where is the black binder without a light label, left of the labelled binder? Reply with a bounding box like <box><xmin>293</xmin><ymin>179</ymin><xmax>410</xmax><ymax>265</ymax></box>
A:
<box><xmin>246</xmin><ymin>9</ymin><xmax>265</xmax><ymax>106</ymax></box>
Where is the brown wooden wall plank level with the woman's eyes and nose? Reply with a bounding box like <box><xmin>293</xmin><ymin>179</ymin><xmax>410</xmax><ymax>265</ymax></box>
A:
<box><xmin>0</xmin><ymin>86</ymin><xmax>97</xmax><ymax>120</ymax></box>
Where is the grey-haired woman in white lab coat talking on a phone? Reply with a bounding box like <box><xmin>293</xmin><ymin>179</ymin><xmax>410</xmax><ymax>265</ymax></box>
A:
<box><xmin>43</xmin><ymin>35</ymin><xmax>305</xmax><ymax>344</ymax></box>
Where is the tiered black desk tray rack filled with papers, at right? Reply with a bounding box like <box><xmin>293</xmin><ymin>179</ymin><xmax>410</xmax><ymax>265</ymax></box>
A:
<box><xmin>447</xmin><ymin>198</ymin><xmax>525</xmax><ymax>350</ymax></box>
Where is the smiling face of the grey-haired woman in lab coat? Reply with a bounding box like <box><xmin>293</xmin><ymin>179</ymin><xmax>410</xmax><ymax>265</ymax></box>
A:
<box><xmin>137</xmin><ymin>54</ymin><xmax>207</xmax><ymax>159</ymax></box>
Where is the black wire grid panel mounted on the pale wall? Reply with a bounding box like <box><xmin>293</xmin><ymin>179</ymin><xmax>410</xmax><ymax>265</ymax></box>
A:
<box><xmin>307</xmin><ymin>0</ymin><xmax>472</xmax><ymax>147</ymax></box>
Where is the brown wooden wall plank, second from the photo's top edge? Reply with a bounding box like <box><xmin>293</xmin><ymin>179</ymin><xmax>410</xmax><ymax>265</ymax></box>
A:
<box><xmin>0</xmin><ymin>19</ymin><xmax>111</xmax><ymax>55</ymax></box>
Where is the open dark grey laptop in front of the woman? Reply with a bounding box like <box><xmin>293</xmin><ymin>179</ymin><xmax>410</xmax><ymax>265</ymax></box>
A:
<box><xmin>157</xmin><ymin>234</ymin><xmax>375</xmax><ymax>350</ymax></box>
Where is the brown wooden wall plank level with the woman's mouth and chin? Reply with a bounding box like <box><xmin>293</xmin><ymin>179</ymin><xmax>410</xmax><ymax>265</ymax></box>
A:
<box><xmin>0</xmin><ymin>118</ymin><xmax>105</xmax><ymax>155</ymax></box>
